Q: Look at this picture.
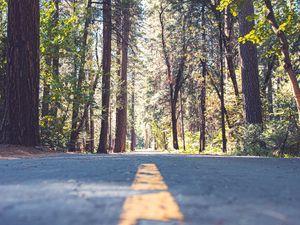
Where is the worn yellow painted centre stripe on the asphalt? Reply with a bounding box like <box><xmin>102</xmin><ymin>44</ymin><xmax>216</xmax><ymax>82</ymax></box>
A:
<box><xmin>119</xmin><ymin>164</ymin><xmax>184</xmax><ymax>225</ymax></box>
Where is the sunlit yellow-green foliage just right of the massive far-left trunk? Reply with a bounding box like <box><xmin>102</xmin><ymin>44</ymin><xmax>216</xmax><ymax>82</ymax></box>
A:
<box><xmin>40</xmin><ymin>0</ymin><xmax>94</xmax><ymax>147</ymax></box>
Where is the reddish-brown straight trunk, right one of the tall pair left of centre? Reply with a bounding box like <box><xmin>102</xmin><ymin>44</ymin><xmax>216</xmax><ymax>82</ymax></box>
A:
<box><xmin>115</xmin><ymin>2</ymin><xmax>130</xmax><ymax>152</ymax></box>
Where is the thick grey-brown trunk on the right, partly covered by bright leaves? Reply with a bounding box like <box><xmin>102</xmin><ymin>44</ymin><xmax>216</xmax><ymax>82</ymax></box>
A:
<box><xmin>239</xmin><ymin>0</ymin><xmax>262</xmax><ymax>124</ymax></box>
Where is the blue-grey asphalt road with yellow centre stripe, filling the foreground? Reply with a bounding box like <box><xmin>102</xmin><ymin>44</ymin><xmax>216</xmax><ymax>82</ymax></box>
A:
<box><xmin>0</xmin><ymin>153</ymin><xmax>300</xmax><ymax>225</ymax></box>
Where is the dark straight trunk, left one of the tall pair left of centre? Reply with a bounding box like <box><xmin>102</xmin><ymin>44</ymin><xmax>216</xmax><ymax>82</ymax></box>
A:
<box><xmin>98</xmin><ymin>0</ymin><xmax>112</xmax><ymax>154</ymax></box>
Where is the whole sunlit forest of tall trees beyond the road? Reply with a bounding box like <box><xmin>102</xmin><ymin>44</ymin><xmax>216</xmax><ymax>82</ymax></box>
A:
<box><xmin>0</xmin><ymin>0</ymin><xmax>300</xmax><ymax>157</ymax></box>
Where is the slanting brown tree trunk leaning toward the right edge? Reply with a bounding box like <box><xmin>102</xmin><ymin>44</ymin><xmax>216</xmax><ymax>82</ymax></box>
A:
<box><xmin>264</xmin><ymin>0</ymin><xmax>300</xmax><ymax>124</ymax></box>
